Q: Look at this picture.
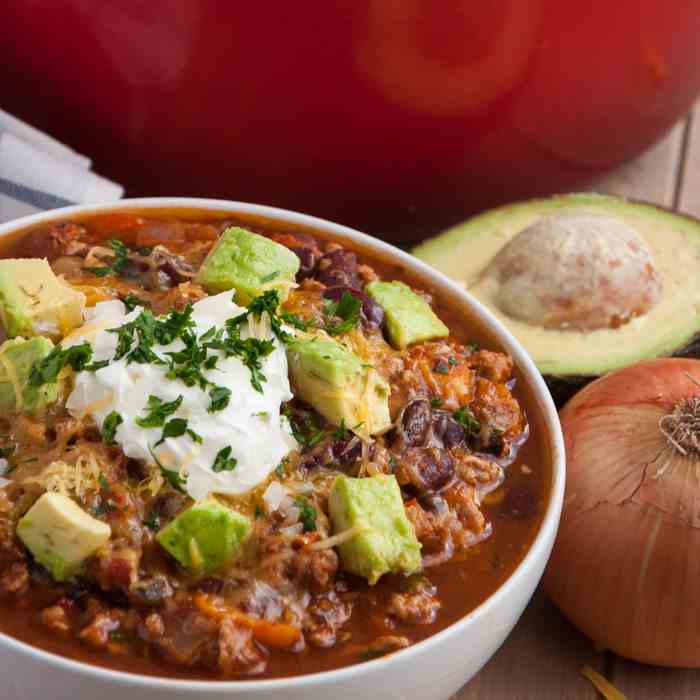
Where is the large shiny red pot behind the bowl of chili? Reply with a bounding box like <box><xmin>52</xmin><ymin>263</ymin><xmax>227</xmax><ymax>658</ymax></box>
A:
<box><xmin>0</xmin><ymin>0</ymin><xmax>700</xmax><ymax>241</ymax></box>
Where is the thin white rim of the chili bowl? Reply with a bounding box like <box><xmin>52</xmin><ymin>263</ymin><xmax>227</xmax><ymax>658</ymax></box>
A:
<box><xmin>0</xmin><ymin>197</ymin><xmax>565</xmax><ymax>694</ymax></box>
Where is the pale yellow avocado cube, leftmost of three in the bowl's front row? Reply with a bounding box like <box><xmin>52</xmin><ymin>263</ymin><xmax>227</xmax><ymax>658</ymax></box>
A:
<box><xmin>17</xmin><ymin>493</ymin><xmax>112</xmax><ymax>581</ymax></box>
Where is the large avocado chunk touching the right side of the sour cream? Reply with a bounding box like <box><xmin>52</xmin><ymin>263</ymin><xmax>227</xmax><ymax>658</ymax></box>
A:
<box><xmin>287</xmin><ymin>337</ymin><xmax>391</xmax><ymax>436</ymax></box>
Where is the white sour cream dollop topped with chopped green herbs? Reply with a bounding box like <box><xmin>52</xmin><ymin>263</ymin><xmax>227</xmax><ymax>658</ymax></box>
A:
<box><xmin>63</xmin><ymin>292</ymin><xmax>297</xmax><ymax>500</ymax></box>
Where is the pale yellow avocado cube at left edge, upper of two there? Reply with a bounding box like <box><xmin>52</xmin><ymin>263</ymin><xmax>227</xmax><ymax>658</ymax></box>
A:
<box><xmin>0</xmin><ymin>258</ymin><xmax>85</xmax><ymax>338</ymax></box>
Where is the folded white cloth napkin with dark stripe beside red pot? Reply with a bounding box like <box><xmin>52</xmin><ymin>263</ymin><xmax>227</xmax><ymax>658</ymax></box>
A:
<box><xmin>0</xmin><ymin>110</ymin><xmax>124</xmax><ymax>223</ymax></box>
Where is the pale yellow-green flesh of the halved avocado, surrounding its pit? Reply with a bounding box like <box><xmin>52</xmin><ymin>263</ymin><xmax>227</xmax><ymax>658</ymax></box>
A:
<box><xmin>413</xmin><ymin>194</ymin><xmax>700</xmax><ymax>384</ymax></box>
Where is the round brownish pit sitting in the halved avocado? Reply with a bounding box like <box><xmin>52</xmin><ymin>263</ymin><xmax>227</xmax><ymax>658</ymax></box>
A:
<box><xmin>485</xmin><ymin>212</ymin><xmax>662</xmax><ymax>331</ymax></box>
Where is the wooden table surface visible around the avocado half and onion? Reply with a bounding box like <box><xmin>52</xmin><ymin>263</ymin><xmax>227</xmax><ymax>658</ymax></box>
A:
<box><xmin>452</xmin><ymin>102</ymin><xmax>700</xmax><ymax>700</ymax></box>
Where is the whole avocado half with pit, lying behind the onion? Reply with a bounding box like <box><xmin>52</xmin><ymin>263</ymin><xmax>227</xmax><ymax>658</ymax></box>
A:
<box><xmin>413</xmin><ymin>194</ymin><xmax>700</xmax><ymax>403</ymax></box>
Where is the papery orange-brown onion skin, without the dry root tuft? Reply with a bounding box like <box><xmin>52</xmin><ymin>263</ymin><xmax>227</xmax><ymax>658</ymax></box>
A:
<box><xmin>544</xmin><ymin>358</ymin><xmax>700</xmax><ymax>667</ymax></box>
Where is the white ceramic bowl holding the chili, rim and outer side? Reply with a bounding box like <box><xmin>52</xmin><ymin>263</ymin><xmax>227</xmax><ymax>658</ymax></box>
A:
<box><xmin>0</xmin><ymin>198</ymin><xmax>564</xmax><ymax>700</ymax></box>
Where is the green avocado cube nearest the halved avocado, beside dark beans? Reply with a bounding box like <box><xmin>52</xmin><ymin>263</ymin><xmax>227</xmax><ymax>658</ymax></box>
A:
<box><xmin>365</xmin><ymin>281</ymin><xmax>450</xmax><ymax>350</ymax></box>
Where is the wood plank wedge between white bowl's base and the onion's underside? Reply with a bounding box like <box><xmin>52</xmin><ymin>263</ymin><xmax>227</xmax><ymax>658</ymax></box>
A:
<box><xmin>453</xmin><ymin>590</ymin><xmax>605</xmax><ymax>700</ymax></box>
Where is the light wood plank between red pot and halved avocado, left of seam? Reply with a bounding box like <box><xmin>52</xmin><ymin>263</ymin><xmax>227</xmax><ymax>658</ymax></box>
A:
<box><xmin>586</xmin><ymin>120</ymin><xmax>688</xmax><ymax>207</ymax></box>
